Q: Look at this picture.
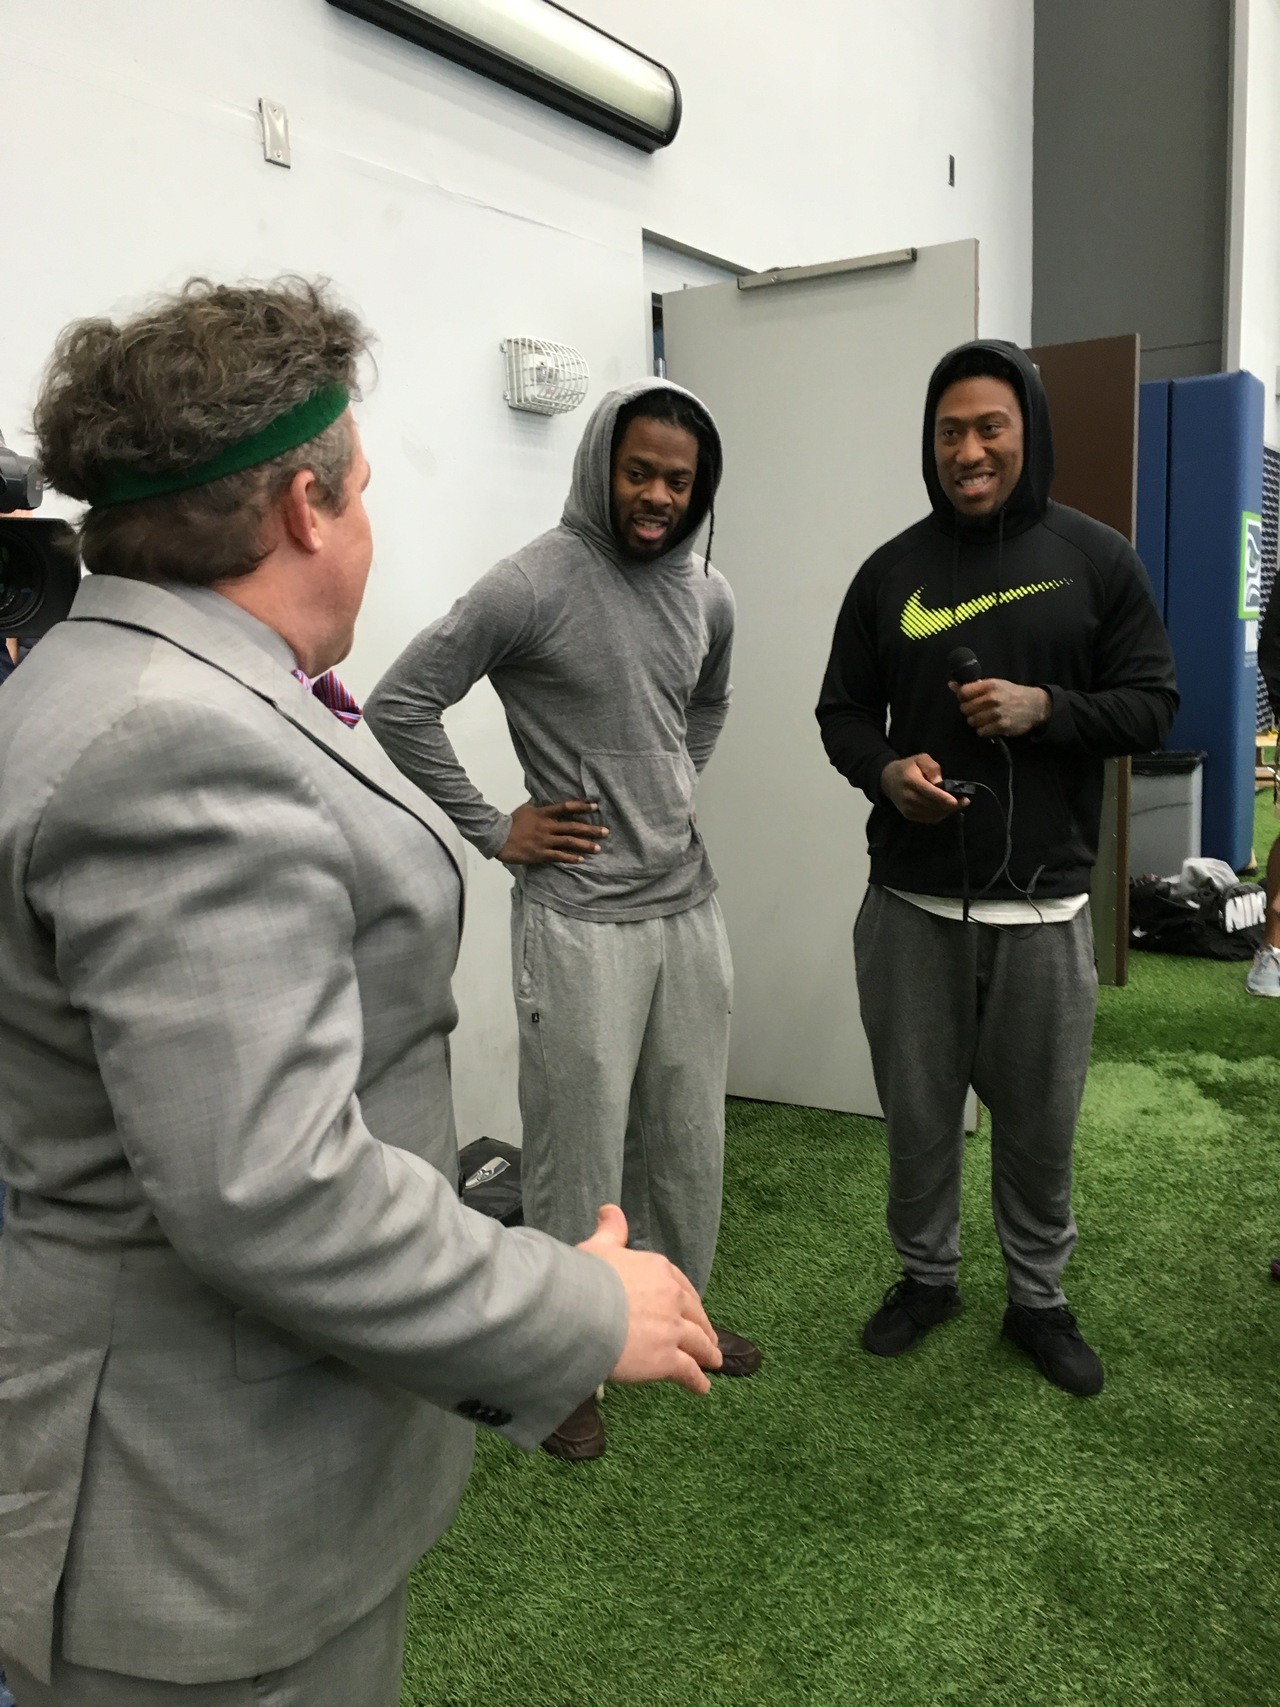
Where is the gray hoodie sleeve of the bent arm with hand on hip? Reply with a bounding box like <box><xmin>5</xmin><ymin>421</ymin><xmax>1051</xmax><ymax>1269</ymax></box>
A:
<box><xmin>365</xmin><ymin>563</ymin><xmax>536</xmax><ymax>859</ymax></box>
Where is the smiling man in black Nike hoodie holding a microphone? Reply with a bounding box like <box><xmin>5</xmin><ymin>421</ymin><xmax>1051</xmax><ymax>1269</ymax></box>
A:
<box><xmin>817</xmin><ymin>341</ymin><xmax>1178</xmax><ymax>1395</ymax></box>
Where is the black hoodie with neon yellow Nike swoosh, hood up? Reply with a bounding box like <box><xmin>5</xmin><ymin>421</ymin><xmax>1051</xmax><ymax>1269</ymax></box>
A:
<box><xmin>817</xmin><ymin>340</ymin><xmax>1178</xmax><ymax>900</ymax></box>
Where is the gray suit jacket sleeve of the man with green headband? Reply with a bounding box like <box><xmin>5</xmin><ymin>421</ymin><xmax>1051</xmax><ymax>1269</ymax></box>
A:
<box><xmin>27</xmin><ymin>703</ymin><xmax>626</xmax><ymax>1448</ymax></box>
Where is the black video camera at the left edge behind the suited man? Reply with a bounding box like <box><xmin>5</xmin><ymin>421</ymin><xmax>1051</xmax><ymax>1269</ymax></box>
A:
<box><xmin>0</xmin><ymin>434</ymin><xmax>80</xmax><ymax>640</ymax></box>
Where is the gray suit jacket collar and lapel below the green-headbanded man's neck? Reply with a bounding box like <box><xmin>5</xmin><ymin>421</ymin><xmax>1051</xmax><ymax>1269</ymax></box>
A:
<box><xmin>67</xmin><ymin>575</ymin><xmax>466</xmax><ymax>888</ymax></box>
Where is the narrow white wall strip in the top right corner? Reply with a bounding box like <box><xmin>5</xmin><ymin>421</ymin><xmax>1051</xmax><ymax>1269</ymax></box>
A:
<box><xmin>1225</xmin><ymin>0</ymin><xmax>1280</xmax><ymax>446</ymax></box>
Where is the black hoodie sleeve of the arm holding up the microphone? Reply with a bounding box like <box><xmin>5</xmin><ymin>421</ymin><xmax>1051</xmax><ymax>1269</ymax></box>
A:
<box><xmin>1033</xmin><ymin>545</ymin><xmax>1178</xmax><ymax>758</ymax></box>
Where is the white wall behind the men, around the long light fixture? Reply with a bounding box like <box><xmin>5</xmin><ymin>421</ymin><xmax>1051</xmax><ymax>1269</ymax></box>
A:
<box><xmin>0</xmin><ymin>0</ymin><xmax>1033</xmax><ymax>1139</ymax></box>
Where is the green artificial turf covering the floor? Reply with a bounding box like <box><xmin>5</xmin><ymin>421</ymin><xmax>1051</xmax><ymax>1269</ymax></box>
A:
<box><xmin>403</xmin><ymin>799</ymin><xmax>1280</xmax><ymax>1707</ymax></box>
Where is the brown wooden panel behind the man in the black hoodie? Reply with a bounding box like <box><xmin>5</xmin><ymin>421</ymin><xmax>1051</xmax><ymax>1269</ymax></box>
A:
<box><xmin>1027</xmin><ymin>333</ymin><xmax>1142</xmax><ymax>985</ymax></box>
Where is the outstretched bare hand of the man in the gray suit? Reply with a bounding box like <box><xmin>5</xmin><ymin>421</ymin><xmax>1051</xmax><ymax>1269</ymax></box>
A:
<box><xmin>579</xmin><ymin>1203</ymin><xmax>722</xmax><ymax>1393</ymax></box>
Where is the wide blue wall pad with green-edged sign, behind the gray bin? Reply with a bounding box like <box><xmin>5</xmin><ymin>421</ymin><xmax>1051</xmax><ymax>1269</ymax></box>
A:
<box><xmin>1166</xmin><ymin>374</ymin><xmax>1263</xmax><ymax>871</ymax></box>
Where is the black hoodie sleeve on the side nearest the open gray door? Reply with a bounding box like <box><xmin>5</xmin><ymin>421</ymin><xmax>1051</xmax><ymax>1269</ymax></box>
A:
<box><xmin>817</xmin><ymin>565</ymin><xmax>899</xmax><ymax>806</ymax></box>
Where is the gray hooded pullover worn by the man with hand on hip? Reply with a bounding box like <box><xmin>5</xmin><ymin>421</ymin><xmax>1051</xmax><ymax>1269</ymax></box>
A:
<box><xmin>365</xmin><ymin>379</ymin><xmax>734</xmax><ymax>922</ymax></box>
